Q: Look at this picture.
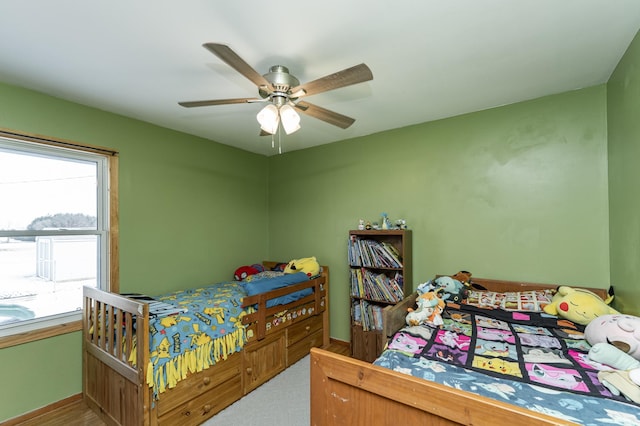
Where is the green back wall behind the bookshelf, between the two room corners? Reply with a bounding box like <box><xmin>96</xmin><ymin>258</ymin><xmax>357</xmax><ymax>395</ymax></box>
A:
<box><xmin>269</xmin><ymin>85</ymin><xmax>609</xmax><ymax>340</ymax></box>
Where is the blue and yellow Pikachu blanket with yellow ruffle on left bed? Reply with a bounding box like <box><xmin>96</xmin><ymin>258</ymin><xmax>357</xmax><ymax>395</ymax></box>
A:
<box><xmin>141</xmin><ymin>281</ymin><xmax>248</xmax><ymax>396</ymax></box>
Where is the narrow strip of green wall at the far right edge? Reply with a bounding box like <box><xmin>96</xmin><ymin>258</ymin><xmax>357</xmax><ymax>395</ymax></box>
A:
<box><xmin>607</xmin><ymin>29</ymin><xmax>640</xmax><ymax>315</ymax></box>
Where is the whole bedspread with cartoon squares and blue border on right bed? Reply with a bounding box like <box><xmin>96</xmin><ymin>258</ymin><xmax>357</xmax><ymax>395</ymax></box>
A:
<box><xmin>374</xmin><ymin>305</ymin><xmax>640</xmax><ymax>425</ymax></box>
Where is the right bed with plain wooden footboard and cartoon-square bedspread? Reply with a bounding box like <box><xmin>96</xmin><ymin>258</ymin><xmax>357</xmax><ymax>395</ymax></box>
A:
<box><xmin>311</xmin><ymin>279</ymin><xmax>640</xmax><ymax>425</ymax></box>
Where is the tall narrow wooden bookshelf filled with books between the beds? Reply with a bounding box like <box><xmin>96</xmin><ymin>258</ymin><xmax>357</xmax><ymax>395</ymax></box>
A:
<box><xmin>348</xmin><ymin>230</ymin><xmax>413</xmax><ymax>362</ymax></box>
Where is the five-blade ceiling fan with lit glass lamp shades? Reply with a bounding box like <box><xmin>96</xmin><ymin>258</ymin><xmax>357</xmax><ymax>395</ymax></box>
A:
<box><xmin>178</xmin><ymin>43</ymin><xmax>373</xmax><ymax>135</ymax></box>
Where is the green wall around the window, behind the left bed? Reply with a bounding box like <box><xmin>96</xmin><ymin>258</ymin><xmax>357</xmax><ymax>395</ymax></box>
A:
<box><xmin>0</xmin><ymin>84</ymin><xmax>268</xmax><ymax>421</ymax></box>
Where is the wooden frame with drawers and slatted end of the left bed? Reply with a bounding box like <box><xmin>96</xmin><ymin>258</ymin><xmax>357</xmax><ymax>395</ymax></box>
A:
<box><xmin>82</xmin><ymin>262</ymin><xmax>329</xmax><ymax>426</ymax></box>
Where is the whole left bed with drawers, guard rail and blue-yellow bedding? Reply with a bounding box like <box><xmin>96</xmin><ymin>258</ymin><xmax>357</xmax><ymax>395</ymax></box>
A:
<box><xmin>83</xmin><ymin>262</ymin><xmax>329</xmax><ymax>426</ymax></box>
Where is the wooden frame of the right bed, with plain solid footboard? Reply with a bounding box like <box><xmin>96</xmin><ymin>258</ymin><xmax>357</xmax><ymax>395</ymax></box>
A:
<box><xmin>311</xmin><ymin>279</ymin><xmax>608</xmax><ymax>426</ymax></box>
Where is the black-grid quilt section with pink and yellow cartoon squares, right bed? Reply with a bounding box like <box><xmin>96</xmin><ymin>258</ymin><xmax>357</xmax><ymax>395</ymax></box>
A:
<box><xmin>376</xmin><ymin>305</ymin><xmax>639</xmax><ymax>420</ymax></box>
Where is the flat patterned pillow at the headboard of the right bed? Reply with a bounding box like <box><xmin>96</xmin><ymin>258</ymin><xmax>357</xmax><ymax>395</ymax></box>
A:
<box><xmin>464</xmin><ymin>289</ymin><xmax>555</xmax><ymax>312</ymax></box>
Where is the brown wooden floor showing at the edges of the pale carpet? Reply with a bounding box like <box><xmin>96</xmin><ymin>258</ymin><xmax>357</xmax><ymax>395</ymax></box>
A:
<box><xmin>10</xmin><ymin>340</ymin><xmax>351</xmax><ymax>426</ymax></box>
